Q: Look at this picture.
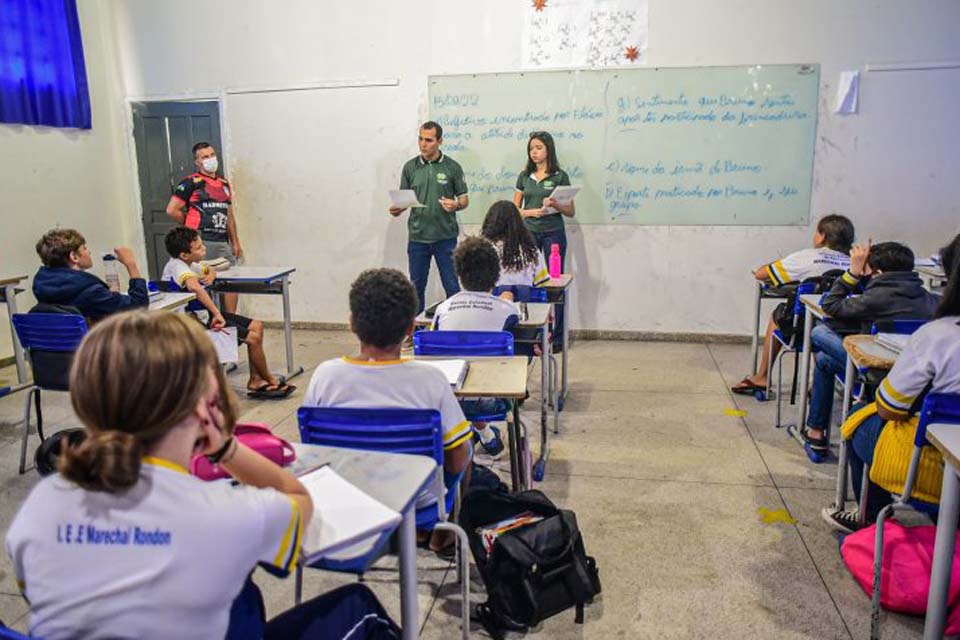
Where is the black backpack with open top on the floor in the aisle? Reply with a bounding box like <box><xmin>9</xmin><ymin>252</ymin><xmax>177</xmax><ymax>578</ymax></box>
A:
<box><xmin>459</xmin><ymin>489</ymin><xmax>600</xmax><ymax>639</ymax></box>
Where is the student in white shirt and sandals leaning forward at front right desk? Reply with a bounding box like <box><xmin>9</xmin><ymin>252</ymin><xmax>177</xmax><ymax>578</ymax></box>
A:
<box><xmin>730</xmin><ymin>213</ymin><xmax>854</xmax><ymax>396</ymax></box>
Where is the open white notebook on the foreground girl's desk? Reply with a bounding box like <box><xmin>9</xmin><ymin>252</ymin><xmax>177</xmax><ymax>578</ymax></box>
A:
<box><xmin>300</xmin><ymin>467</ymin><xmax>400</xmax><ymax>559</ymax></box>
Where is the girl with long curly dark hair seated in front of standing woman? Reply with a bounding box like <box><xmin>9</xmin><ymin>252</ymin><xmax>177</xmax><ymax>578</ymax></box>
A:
<box><xmin>480</xmin><ymin>200</ymin><xmax>550</xmax><ymax>300</ymax></box>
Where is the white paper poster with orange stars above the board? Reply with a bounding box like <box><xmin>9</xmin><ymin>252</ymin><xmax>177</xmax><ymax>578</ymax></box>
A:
<box><xmin>522</xmin><ymin>0</ymin><xmax>648</xmax><ymax>69</ymax></box>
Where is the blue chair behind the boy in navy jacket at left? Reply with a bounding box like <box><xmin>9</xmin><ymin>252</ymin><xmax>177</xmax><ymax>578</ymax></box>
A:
<box><xmin>13</xmin><ymin>313</ymin><xmax>87</xmax><ymax>474</ymax></box>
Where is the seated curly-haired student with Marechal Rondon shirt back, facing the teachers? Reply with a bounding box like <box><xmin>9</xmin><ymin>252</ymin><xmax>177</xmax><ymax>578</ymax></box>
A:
<box><xmin>433</xmin><ymin>237</ymin><xmax>520</xmax><ymax>457</ymax></box>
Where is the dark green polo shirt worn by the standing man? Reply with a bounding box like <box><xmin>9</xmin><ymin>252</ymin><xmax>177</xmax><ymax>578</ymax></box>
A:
<box><xmin>400</xmin><ymin>152</ymin><xmax>467</xmax><ymax>242</ymax></box>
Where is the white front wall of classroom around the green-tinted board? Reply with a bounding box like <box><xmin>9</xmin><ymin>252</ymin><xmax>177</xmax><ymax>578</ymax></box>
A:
<box><xmin>101</xmin><ymin>0</ymin><xmax>960</xmax><ymax>334</ymax></box>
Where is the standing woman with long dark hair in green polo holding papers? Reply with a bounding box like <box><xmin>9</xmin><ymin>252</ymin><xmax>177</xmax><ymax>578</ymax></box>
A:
<box><xmin>513</xmin><ymin>131</ymin><xmax>576</xmax><ymax>351</ymax></box>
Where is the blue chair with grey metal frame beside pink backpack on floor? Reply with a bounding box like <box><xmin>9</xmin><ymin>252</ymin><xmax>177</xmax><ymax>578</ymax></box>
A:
<box><xmin>860</xmin><ymin>393</ymin><xmax>960</xmax><ymax>638</ymax></box>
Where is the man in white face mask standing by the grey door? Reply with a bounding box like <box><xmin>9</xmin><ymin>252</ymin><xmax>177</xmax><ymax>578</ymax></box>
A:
<box><xmin>167</xmin><ymin>142</ymin><xmax>243</xmax><ymax>313</ymax></box>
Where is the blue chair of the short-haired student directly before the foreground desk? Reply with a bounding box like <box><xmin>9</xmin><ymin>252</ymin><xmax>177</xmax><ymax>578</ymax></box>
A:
<box><xmin>296</xmin><ymin>408</ymin><xmax>470</xmax><ymax>638</ymax></box>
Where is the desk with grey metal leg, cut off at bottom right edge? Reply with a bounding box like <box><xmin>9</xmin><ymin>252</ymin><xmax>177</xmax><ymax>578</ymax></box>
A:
<box><xmin>923</xmin><ymin>424</ymin><xmax>960</xmax><ymax>640</ymax></box>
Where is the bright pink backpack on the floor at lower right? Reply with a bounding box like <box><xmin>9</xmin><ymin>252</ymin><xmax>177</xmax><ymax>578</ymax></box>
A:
<box><xmin>840</xmin><ymin>520</ymin><xmax>960</xmax><ymax>636</ymax></box>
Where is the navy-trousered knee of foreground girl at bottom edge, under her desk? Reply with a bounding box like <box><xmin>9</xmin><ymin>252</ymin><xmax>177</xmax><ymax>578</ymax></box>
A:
<box><xmin>263</xmin><ymin>583</ymin><xmax>400</xmax><ymax>640</ymax></box>
